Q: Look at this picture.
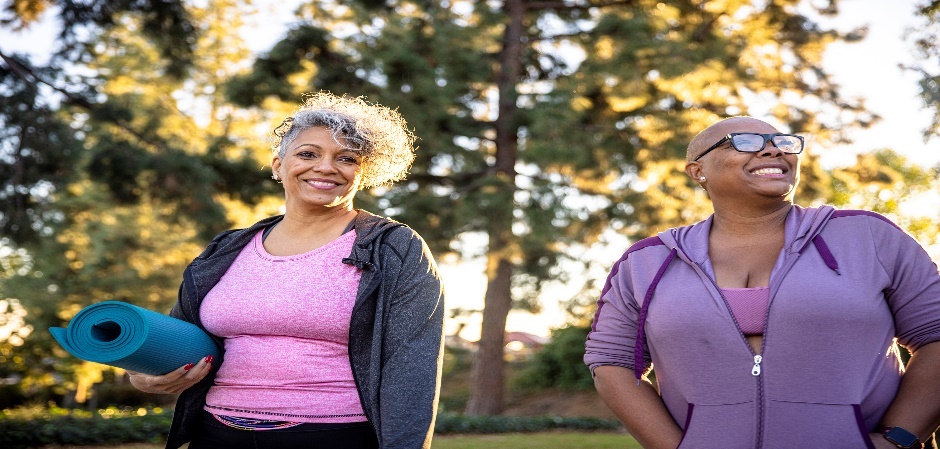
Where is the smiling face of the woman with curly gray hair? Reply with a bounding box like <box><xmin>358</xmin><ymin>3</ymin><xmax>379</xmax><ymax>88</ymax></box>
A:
<box><xmin>271</xmin><ymin>127</ymin><xmax>362</xmax><ymax>212</ymax></box>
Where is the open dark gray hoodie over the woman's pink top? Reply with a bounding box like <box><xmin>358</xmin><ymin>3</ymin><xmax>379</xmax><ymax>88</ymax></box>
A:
<box><xmin>166</xmin><ymin>210</ymin><xmax>444</xmax><ymax>449</ymax></box>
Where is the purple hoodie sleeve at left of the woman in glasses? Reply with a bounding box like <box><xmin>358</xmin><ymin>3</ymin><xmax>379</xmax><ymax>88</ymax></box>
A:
<box><xmin>584</xmin><ymin>259</ymin><xmax>651</xmax><ymax>373</ymax></box>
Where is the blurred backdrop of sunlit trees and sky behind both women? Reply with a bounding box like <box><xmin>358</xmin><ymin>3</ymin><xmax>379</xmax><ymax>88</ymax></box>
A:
<box><xmin>0</xmin><ymin>0</ymin><xmax>940</xmax><ymax>436</ymax></box>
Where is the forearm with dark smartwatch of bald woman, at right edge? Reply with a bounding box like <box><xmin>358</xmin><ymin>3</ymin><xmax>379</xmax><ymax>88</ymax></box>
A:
<box><xmin>881</xmin><ymin>342</ymin><xmax>940</xmax><ymax>441</ymax></box>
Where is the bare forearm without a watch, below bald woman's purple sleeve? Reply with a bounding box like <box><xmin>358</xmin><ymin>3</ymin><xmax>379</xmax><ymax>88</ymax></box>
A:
<box><xmin>594</xmin><ymin>366</ymin><xmax>682</xmax><ymax>449</ymax></box>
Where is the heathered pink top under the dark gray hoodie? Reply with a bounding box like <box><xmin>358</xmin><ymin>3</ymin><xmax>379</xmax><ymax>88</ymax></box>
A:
<box><xmin>199</xmin><ymin>232</ymin><xmax>366</xmax><ymax>423</ymax></box>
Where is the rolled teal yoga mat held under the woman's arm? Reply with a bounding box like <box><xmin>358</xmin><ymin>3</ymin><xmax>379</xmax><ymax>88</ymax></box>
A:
<box><xmin>49</xmin><ymin>301</ymin><xmax>219</xmax><ymax>375</ymax></box>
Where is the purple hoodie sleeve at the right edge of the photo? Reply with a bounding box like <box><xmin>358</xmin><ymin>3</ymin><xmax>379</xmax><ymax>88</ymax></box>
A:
<box><xmin>868</xmin><ymin>216</ymin><xmax>940</xmax><ymax>352</ymax></box>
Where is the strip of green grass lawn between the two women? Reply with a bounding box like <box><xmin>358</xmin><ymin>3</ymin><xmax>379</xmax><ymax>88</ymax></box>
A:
<box><xmin>38</xmin><ymin>432</ymin><xmax>640</xmax><ymax>449</ymax></box>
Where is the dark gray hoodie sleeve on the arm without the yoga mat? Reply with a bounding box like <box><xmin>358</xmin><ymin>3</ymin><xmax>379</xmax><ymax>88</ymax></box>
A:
<box><xmin>378</xmin><ymin>227</ymin><xmax>444</xmax><ymax>449</ymax></box>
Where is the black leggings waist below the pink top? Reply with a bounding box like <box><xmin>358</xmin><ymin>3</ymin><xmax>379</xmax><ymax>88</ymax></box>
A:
<box><xmin>189</xmin><ymin>411</ymin><xmax>379</xmax><ymax>449</ymax></box>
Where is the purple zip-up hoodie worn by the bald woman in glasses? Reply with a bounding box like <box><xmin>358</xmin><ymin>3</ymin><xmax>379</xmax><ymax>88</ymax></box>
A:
<box><xmin>584</xmin><ymin>206</ymin><xmax>940</xmax><ymax>449</ymax></box>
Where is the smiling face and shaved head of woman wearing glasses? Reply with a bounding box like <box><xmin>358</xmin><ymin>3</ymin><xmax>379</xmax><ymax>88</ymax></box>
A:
<box><xmin>686</xmin><ymin>117</ymin><xmax>800</xmax><ymax>202</ymax></box>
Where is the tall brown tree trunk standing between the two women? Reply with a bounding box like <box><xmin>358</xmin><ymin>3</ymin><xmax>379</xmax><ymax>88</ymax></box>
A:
<box><xmin>467</xmin><ymin>0</ymin><xmax>525</xmax><ymax>415</ymax></box>
